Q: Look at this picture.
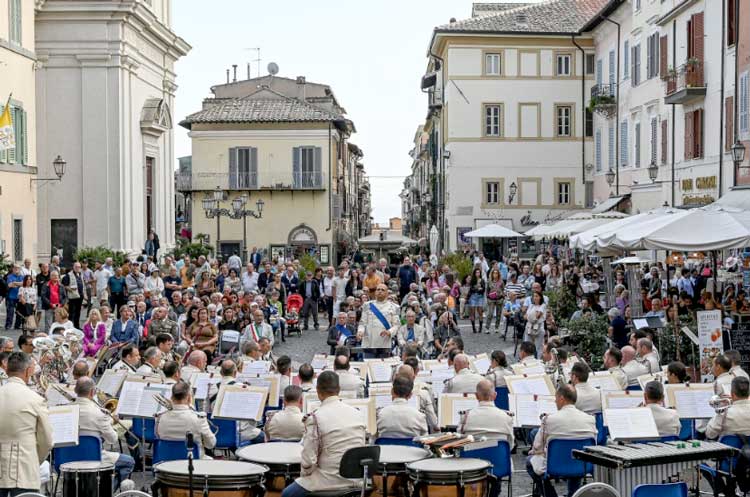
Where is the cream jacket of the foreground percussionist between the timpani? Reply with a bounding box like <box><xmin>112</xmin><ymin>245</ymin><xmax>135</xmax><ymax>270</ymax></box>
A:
<box><xmin>296</xmin><ymin>396</ymin><xmax>365</xmax><ymax>492</ymax></box>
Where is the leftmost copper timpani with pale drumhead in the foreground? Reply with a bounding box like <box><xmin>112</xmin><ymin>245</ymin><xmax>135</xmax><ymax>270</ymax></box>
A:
<box><xmin>154</xmin><ymin>459</ymin><xmax>268</xmax><ymax>497</ymax></box>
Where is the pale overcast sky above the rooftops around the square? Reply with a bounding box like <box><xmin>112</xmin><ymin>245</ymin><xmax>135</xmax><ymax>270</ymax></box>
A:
<box><xmin>173</xmin><ymin>0</ymin><xmax>478</xmax><ymax>222</ymax></box>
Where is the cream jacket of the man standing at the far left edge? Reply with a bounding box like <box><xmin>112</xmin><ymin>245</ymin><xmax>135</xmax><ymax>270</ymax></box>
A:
<box><xmin>0</xmin><ymin>377</ymin><xmax>52</xmax><ymax>490</ymax></box>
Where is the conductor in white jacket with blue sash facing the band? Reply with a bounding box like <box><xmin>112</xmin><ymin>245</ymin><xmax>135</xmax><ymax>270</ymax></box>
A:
<box><xmin>357</xmin><ymin>284</ymin><xmax>401</xmax><ymax>358</ymax></box>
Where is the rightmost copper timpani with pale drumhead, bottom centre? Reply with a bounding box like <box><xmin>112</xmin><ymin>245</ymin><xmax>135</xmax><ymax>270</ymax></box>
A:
<box><xmin>406</xmin><ymin>458</ymin><xmax>492</xmax><ymax>497</ymax></box>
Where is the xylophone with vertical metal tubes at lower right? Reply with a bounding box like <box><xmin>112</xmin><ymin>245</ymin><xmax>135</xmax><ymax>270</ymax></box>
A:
<box><xmin>573</xmin><ymin>440</ymin><xmax>735</xmax><ymax>496</ymax></box>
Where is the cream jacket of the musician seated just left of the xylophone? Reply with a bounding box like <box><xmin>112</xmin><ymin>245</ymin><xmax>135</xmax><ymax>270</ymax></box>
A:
<box><xmin>531</xmin><ymin>405</ymin><xmax>597</xmax><ymax>475</ymax></box>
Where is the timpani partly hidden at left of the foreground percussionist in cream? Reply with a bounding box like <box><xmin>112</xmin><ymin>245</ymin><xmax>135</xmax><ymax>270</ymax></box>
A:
<box><xmin>235</xmin><ymin>442</ymin><xmax>302</xmax><ymax>496</ymax></box>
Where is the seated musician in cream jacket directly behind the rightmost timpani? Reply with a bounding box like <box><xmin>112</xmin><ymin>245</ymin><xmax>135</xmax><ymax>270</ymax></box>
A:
<box><xmin>458</xmin><ymin>380</ymin><xmax>514</xmax><ymax>448</ymax></box>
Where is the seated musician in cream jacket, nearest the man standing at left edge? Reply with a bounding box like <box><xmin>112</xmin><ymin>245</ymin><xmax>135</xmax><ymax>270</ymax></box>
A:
<box><xmin>73</xmin><ymin>376</ymin><xmax>135</xmax><ymax>489</ymax></box>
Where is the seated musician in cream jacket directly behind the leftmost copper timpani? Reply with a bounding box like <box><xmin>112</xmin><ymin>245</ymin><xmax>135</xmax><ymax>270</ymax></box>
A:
<box><xmin>154</xmin><ymin>380</ymin><xmax>216</xmax><ymax>458</ymax></box>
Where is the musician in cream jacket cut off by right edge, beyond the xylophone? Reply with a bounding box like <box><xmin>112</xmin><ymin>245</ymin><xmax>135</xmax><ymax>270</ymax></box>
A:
<box><xmin>701</xmin><ymin>376</ymin><xmax>750</xmax><ymax>497</ymax></box>
